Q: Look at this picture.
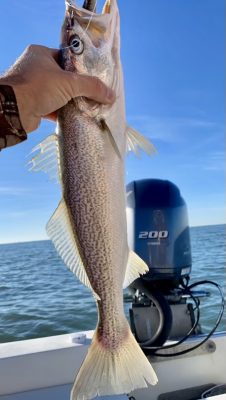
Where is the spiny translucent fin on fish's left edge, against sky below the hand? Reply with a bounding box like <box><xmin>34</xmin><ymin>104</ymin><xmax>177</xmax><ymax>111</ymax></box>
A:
<box><xmin>29</xmin><ymin>133</ymin><xmax>61</xmax><ymax>181</ymax></box>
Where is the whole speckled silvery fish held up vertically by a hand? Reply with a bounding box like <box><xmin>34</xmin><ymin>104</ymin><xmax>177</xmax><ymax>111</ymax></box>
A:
<box><xmin>31</xmin><ymin>0</ymin><xmax>158</xmax><ymax>400</ymax></box>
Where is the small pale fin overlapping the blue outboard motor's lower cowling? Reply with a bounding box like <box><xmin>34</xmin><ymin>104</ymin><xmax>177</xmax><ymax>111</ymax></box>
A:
<box><xmin>123</xmin><ymin>250</ymin><xmax>149</xmax><ymax>289</ymax></box>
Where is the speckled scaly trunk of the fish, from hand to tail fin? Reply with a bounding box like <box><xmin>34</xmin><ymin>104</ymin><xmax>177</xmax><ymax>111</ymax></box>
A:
<box><xmin>59</xmin><ymin>104</ymin><xmax>129</xmax><ymax>338</ymax></box>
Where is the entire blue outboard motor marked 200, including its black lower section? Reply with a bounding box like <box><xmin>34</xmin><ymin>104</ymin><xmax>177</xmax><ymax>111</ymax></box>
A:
<box><xmin>127</xmin><ymin>179</ymin><xmax>198</xmax><ymax>346</ymax></box>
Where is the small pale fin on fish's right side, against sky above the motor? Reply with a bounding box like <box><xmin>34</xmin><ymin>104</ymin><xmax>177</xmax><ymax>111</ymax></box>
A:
<box><xmin>126</xmin><ymin>126</ymin><xmax>157</xmax><ymax>157</ymax></box>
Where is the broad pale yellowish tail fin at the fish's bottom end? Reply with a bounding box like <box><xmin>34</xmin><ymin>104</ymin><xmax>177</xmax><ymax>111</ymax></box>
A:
<box><xmin>71</xmin><ymin>327</ymin><xmax>158</xmax><ymax>400</ymax></box>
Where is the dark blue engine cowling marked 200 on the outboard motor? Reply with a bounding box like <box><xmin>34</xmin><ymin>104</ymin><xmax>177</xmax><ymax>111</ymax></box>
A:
<box><xmin>127</xmin><ymin>179</ymin><xmax>192</xmax><ymax>282</ymax></box>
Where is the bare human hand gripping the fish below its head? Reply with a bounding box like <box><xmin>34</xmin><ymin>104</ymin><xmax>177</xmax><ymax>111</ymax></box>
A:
<box><xmin>0</xmin><ymin>45</ymin><xmax>115</xmax><ymax>133</ymax></box>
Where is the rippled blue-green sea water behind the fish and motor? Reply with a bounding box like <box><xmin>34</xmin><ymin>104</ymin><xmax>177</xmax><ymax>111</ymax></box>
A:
<box><xmin>0</xmin><ymin>225</ymin><xmax>226</xmax><ymax>343</ymax></box>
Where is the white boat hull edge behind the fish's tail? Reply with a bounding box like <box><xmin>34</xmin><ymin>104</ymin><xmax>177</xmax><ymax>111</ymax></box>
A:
<box><xmin>0</xmin><ymin>331</ymin><xmax>226</xmax><ymax>400</ymax></box>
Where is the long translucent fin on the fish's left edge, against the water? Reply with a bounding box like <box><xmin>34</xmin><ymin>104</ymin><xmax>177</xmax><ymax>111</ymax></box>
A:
<box><xmin>46</xmin><ymin>200</ymin><xmax>100</xmax><ymax>300</ymax></box>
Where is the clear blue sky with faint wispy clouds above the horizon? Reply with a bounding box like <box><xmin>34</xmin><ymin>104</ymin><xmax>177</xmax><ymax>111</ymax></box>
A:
<box><xmin>0</xmin><ymin>0</ymin><xmax>225</xmax><ymax>243</ymax></box>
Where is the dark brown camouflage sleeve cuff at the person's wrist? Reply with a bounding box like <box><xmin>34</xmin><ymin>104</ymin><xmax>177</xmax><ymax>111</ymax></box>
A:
<box><xmin>0</xmin><ymin>85</ymin><xmax>27</xmax><ymax>150</ymax></box>
